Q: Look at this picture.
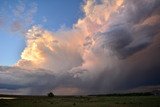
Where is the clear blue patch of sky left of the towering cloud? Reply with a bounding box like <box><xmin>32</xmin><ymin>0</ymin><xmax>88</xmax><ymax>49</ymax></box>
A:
<box><xmin>0</xmin><ymin>0</ymin><xmax>83</xmax><ymax>66</ymax></box>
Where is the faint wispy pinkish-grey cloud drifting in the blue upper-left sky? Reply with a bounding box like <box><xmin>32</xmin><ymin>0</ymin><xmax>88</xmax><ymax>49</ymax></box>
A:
<box><xmin>11</xmin><ymin>1</ymin><xmax>37</xmax><ymax>32</ymax></box>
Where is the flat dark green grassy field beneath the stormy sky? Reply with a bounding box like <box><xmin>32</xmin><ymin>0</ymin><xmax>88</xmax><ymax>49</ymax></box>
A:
<box><xmin>0</xmin><ymin>96</ymin><xmax>160</xmax><ymax>107</ymax></box>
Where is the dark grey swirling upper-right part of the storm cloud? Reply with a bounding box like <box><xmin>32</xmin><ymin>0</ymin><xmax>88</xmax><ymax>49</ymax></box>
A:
<box><xmin>89</xmin><ymin>0</ymin><xmax>160</xmax><ymax>57</ymax></box>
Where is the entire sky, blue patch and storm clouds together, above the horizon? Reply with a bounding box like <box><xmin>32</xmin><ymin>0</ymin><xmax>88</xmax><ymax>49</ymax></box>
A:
<box><xmin>0</xmin><ymin>0</ymin><xmax>160</xmax><ymax>95</ymax></box>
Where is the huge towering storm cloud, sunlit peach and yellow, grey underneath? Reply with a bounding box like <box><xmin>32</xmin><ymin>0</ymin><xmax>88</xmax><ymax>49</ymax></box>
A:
<box><xmin>0</xmin><ymin>0</ymin><xmax>160</xmax><ymax>94</ymax></box>
